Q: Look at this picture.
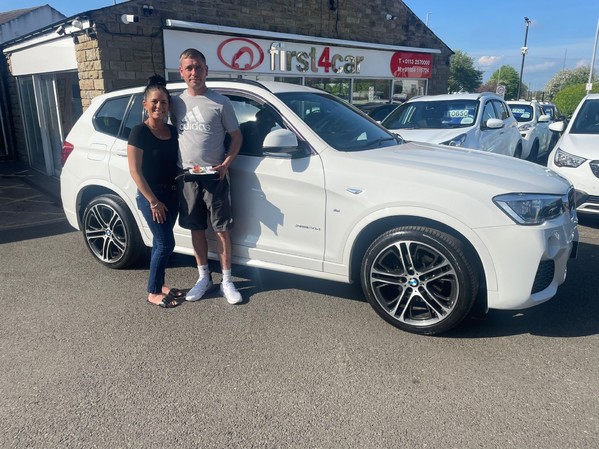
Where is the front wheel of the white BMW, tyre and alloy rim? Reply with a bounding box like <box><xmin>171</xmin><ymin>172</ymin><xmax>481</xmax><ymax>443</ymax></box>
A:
<box><xmin>361</xmin><ymin>226</ymin><xmax>478</xmax><ymax>335</ymax></box>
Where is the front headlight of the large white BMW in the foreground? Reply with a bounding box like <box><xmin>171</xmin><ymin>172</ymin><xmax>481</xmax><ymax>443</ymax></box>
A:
<box><xmin>493</xmin><ymin>193</ymin><xmax>564</xmax><ymax>225</ymax></box>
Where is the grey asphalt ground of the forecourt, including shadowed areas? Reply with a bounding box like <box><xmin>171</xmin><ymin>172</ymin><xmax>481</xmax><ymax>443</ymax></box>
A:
<box><xmin>0</xmin><ymin>164</ymin><xmax>599</xmax><ymax>448</ymax></box>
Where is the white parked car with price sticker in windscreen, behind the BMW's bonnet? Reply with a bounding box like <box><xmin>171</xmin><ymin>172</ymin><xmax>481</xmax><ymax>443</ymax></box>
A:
<box><xmin>382</xmin><ymin>92</ymin><xmax>523</xmax><ymax>157</ymax></box>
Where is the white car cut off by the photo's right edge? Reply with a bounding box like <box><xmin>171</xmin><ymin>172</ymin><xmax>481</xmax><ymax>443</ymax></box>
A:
<box><xmin>547</xmin><ymin>94</ymin><xmax>599</xmax><ymax>214</ymax></box>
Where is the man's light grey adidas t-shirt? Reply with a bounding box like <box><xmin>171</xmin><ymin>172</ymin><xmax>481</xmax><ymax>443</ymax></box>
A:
<box><xmin>171</xmin><ymin>89</ymin><xmax>239</xmax><ymax>170</ymax></box>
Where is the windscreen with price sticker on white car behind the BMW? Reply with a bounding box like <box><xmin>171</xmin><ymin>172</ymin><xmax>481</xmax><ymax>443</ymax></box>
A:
<box><xmin>382</xmin><ymin>99</ymin><xmax>478</xmax><ymax>129</ymax></box>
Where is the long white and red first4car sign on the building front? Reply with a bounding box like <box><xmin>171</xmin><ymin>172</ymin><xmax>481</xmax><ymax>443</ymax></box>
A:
<box><xmin>164</xmin><ymin>30</ymin><xmax>432</xmax><ymax>78</ymax></box>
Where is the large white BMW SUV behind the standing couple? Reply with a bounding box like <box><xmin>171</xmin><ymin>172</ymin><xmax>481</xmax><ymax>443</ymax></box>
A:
<box><xmin>61</xmin><ymin>80</ymin><xmax>578</xmax><ymax>334</ymax></box>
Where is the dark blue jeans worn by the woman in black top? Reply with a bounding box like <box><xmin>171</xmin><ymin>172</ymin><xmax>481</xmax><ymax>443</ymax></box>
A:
<box><xmin>136</xmin><ymin>185</ymin><xmax>179</xmax><ymax>293</ymax></box>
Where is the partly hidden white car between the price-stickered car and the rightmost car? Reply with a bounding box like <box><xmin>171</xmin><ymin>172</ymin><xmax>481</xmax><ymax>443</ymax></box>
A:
<box><xmin>507</xmin><ymin>100</ymin><xmax>553</xmax><ymax>162</ymax></box>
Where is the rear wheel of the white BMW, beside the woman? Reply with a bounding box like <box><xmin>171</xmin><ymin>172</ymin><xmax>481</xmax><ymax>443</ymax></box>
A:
<box><xmin>82</xmin><ymin>195</ymin><xmax>145</xmax><ymax>269</ymax></box>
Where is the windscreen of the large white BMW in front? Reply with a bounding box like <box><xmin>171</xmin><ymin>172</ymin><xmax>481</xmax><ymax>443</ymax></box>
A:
<box><xmin>277</xmin><ymin>92</ymin><xmax>401</xmax><ymax>151</ymax></box>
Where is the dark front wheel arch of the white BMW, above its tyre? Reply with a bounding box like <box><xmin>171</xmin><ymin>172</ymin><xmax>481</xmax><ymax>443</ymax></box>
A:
<box><xmin>349</xmin><ymin>215</ymin><xmax>487</xmax><ymax>310</ymax></box>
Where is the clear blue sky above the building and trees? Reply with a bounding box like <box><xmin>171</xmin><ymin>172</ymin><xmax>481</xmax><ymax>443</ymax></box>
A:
<box><xmin>5</xmin><ymin>0</ymin><xmax>599</xmax><ymax>90</ymax></box>
